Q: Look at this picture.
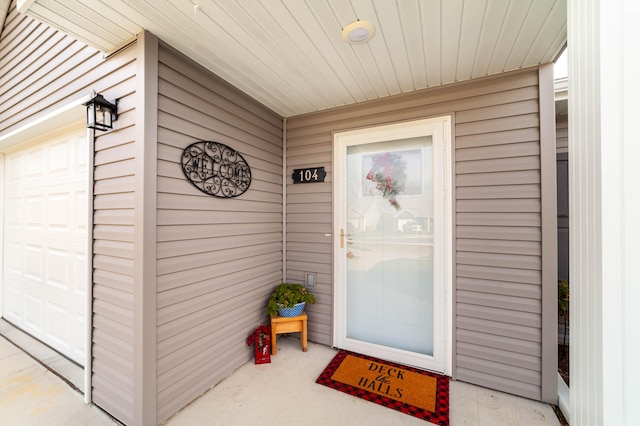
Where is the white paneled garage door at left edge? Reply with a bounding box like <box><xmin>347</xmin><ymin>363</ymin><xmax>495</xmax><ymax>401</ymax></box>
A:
<box><xmin>2</xmin><ymin>129</ymin><xmax>88</xmax><ymax>365</ymax></box>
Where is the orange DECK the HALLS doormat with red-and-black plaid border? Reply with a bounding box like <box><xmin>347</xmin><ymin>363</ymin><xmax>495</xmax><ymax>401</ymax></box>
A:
<box><xmin>316</xmin><ymin>350</ymin><xmax>449</xmax><ymax>426</ymax></box>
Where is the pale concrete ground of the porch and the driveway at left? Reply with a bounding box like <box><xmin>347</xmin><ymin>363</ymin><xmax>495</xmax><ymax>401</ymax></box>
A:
<box><xmin>0</xmin><ymin>323</ymin><xmax>560</xmax><ymax>426</ymax></box>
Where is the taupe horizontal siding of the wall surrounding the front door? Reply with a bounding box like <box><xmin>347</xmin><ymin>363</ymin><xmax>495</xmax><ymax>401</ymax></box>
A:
<box><xmin>286</xmin><ymin>69</ymin><xmax>543</xmax><ymax>399</ymax></box>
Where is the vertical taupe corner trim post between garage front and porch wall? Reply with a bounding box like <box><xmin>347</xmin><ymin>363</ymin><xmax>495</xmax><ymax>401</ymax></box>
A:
<box><xmin>134</xmin><ymin>31</ymin><xmax>158</xmax><ymax>425</ymax></box>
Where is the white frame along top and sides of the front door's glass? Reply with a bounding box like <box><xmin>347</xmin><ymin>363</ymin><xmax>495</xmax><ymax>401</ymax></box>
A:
<box><xmin>333</xmin><ymin>116</ymin><xmax>453</xmax><ymax>375</ymax></box>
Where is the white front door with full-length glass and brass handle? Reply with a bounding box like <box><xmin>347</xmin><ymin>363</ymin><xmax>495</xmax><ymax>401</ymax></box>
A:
<box><xmin>334</xmin><ymin>117</ymin><xmax>451</xmax><ymax>373</ymax></box>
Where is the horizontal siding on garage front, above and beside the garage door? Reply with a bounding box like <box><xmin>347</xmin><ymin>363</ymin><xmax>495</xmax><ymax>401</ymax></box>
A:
<box><xmin>0</xmin><ymin>2</ymin><xmax>136</xmax><ymax>424</ymax></box>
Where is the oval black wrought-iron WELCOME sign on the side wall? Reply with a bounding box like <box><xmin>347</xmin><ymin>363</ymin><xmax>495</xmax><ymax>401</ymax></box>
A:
<box><xmin>182</xmin><ymin>141</ymin><xmax>251</xmax><ymax>198</ymax></box>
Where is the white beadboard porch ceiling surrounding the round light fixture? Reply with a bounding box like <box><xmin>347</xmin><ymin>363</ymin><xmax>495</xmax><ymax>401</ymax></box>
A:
<box><xmin>13</xmin><ymin>0</ymin><xmax>567</xmax><ymax>117</ymax></box>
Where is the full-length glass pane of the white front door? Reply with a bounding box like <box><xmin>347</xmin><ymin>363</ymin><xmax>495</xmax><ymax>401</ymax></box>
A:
<box><xmin>346</xmin><ymin>136</ymin><xmax>434</xmax><ymax>356</ymax></box>
